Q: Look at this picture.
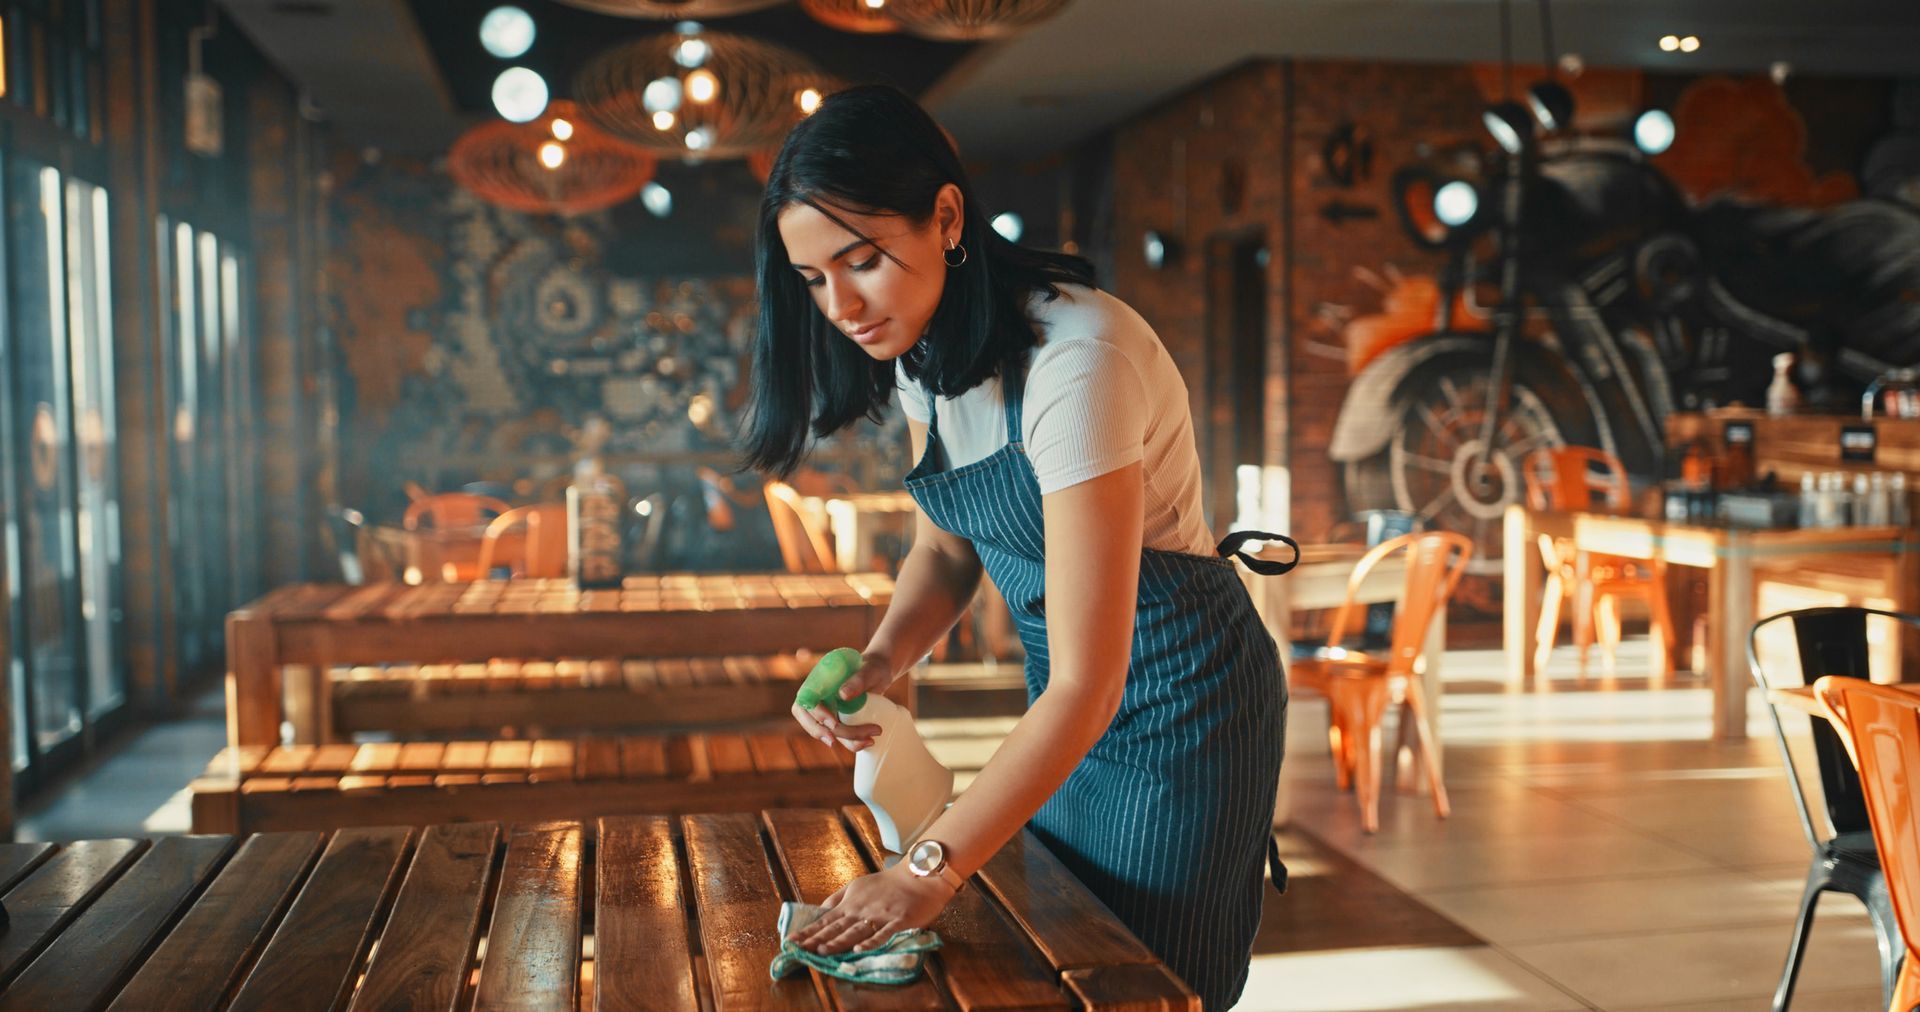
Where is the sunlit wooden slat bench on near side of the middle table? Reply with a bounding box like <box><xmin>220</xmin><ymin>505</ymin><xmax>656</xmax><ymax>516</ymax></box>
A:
<box><xmin>190</xmin><ymin>732</ymin><xmax>854</xmax><ymax>833</ymax></box>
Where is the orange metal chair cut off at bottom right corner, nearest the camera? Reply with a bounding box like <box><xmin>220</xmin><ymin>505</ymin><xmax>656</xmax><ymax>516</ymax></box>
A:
<box><xmin>1812</xmin><ymin>674</ymin><xmax>1920</xmax><ymax>1012</ymax></box>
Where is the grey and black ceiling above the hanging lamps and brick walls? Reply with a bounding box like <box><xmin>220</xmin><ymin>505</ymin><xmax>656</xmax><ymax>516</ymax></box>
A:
<box><xmin>221</xmin><ymin>0</ymin><xmax>1920</xmax><ymax>157</ymax></box>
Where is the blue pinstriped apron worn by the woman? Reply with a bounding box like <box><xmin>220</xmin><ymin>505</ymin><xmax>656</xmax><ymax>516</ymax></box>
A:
<box><xmin>906</xmin><ymin>361</ymin><xmax>1298</xmax><ymax>1008</ymax></box>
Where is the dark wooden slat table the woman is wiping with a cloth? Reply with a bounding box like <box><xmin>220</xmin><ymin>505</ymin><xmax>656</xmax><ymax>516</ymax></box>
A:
<box><xmin>0</xmin><ymin>808</ymin><xmax>1200</xmax><ymax>1012</ymax></box>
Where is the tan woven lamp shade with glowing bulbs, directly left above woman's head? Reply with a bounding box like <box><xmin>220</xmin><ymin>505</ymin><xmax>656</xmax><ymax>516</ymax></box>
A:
<box><xmin>572</xmin><ymin>31</ymin><xmax>833</xmax><ymax>159</ymax></box>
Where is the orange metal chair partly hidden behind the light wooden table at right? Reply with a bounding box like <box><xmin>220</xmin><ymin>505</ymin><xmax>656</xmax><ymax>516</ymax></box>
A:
<box><xmin>1521</xmin><ymin>446</ymin><xmax>1674</xmax><ymax>678</ymax></box>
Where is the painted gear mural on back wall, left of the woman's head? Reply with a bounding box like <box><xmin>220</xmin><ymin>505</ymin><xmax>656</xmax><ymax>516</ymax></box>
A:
<box><xmin>330</xmin><ymin>155</ymin><xmax>906</xmax><ymax>568</ymax></box>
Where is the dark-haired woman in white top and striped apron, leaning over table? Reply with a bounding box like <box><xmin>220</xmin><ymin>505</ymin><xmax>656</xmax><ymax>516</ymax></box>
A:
<box><xmin>747</xmin><ymin>86</ymin><xmax>1286</xmax><ymax>1008</ymax></box>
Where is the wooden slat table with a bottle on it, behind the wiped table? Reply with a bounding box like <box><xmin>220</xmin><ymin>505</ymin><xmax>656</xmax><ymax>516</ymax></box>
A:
<box><xmin>227</xmin><ymin>572</ymin><xmax>893</xmax><ymax>747</ymax></box>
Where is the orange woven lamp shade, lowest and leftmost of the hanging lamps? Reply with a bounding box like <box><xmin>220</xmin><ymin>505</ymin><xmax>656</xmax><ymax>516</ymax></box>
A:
<box><xmin>447</xmin><ymin>100</ymin><xmax>655</xmax><ymax>215</ymax></box>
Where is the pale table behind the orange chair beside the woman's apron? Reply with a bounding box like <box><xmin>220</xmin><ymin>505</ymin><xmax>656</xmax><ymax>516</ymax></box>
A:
<box><xmin>1236</xmin><ymin>543</ymin><xmax>1446</xmax><ymax>826</ymax></box>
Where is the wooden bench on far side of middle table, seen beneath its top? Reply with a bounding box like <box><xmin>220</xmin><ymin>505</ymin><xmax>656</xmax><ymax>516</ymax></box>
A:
<box><xmin>328</xmin><ymin>653</ymin><xmax>914</xmax><ymax>737</ymax></box>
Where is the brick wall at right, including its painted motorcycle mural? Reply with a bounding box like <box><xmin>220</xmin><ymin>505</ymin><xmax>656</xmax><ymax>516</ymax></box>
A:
<box><xmin>1114</xmin><ymin>60</ymin><xmax>1920</xmax><ymax>613</ymax></box>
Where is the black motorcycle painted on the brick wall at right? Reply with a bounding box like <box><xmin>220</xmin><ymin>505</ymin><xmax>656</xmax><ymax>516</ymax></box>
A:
<box><xmin>1329</xmin><ymin>82</ymin><xmax>1920</xmax><ymax>572</ymax></box>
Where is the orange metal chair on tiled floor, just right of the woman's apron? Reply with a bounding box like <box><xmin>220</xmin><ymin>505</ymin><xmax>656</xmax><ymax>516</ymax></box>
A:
<box><xmin>1286</xmin><ymin>530</ymin><xmax>1473</xmax><ymax>833</ymax></box>
